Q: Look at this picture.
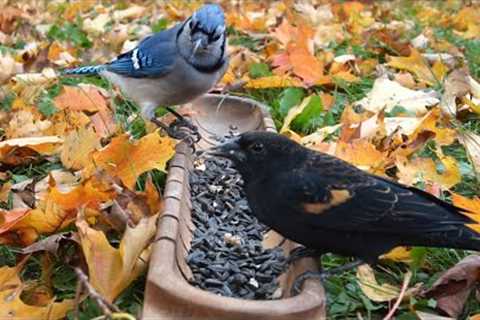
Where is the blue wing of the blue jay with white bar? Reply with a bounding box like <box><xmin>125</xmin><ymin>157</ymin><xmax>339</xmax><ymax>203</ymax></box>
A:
<box><xmin>106</xmin><ymin>25</ymin><xmax>180</xmax><ymax>78</ymax></box>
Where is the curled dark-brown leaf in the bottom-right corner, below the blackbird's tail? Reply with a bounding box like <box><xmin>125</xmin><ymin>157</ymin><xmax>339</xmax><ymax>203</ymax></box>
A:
<box><xmin>425</xmin><ymin>255</ymin><xmax>480</xmax><ymax>318</ymax></box>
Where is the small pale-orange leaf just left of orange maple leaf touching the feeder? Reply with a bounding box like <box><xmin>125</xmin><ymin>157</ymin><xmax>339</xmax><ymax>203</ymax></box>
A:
<box><xmin>60</xmin><ymin>128</ymin><xmax>100</xmax><ymax>170</ymax></box>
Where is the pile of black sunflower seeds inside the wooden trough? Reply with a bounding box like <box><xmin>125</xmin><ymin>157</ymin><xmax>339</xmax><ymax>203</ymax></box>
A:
<box><xmin>187</xmin><ymin>157</ymin><xmax>286</xmax><ymax>299</ymax></box>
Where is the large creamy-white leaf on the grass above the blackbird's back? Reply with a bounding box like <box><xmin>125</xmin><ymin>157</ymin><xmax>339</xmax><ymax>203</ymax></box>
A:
<box><xmin>355</xmin><ymin>77</ymin><xmax>440</xmax><ymax>115</ymax></box>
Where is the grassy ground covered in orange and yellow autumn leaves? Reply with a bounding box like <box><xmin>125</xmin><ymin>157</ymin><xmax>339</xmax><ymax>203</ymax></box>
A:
<box><xmin>0</xmin><ymin>0</ymin><xmax>480</xmax><ymax>319</ymax></box>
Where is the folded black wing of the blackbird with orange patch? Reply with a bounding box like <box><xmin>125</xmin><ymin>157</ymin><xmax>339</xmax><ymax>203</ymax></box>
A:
<box><xmin>275</xmin><ymin>157</ymin><xmax>472</xmax><ymax>233</ymax></box>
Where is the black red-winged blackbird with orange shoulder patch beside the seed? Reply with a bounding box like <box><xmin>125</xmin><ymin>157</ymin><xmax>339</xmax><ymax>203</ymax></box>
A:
<box><xmin>210</xmin><ymin>132</ymin><xmax>480</xmax><ymax>289</ymax></box>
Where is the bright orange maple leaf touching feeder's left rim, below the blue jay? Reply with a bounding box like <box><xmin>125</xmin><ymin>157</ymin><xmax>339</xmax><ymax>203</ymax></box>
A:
<box><xmin>86</xmin><ymin>132</ymin><xmax>174</xmax><ymax>189</ymax></box>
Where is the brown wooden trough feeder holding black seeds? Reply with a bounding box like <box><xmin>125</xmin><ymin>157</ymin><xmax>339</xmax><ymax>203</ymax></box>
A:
<box><xmin>142</xmin><ymin>95</ymin><xmax>325</xmax><ymax>320</ymax></box>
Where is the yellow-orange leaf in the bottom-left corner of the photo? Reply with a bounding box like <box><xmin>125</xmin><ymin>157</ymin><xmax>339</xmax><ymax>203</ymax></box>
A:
<box><xmin>0</xmin><ymin>262</ymin><xmax>75</xmax><ymax>320</ymax></box>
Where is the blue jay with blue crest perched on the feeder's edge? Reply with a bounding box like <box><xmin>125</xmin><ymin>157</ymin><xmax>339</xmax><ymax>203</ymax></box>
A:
<box><xmin>64</xmin><ymin>4</ymin><xmax>228</xmax><ymax>138</ymax></box>
